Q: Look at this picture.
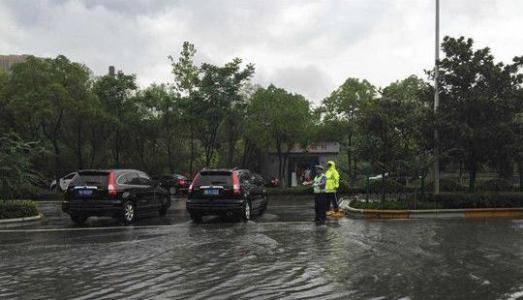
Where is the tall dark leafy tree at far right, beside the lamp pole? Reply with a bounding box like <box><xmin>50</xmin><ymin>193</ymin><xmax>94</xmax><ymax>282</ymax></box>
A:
<box><xmin>437</xmin><ymin>37</ymin><xmax>523</xmax><ymax>192</ymax></box>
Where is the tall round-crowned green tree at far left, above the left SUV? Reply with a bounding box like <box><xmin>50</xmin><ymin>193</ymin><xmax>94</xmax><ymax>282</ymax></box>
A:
<box><xmin>5</xmin><ymin>55</ymin><xmax>89</xmax><ymax>178</ymax></box>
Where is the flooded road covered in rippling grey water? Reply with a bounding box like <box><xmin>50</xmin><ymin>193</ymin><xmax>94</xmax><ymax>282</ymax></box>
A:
<box><xmin>0</xmin><ymin>200</ymin><xmax>523</xmax><ymax>299</ymax></box>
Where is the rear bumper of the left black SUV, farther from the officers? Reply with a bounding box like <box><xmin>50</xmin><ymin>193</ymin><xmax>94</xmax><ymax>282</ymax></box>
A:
<box><xmin>62</xmin><ymin>200</ymin><xmax>122</xmax><ymax>216</ymax></box>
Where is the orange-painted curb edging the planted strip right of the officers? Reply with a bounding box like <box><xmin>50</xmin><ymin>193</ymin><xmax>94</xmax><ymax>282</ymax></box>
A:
<box><xmin>346</xmin><ymin>206</ymin><xmax>523</xmax><ymax>219</ymax></box>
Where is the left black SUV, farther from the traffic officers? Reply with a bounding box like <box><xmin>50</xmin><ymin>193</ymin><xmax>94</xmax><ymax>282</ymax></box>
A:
<box><xmin>62</xmin><ymin>170</ymin><xmax>171</xmax><ymax>225</ymax></box>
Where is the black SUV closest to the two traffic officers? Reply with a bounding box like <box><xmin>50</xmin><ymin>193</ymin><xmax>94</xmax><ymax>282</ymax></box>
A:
<box><xmin>187</xmin><ymin>169</ymin><xmax>268</xmax><ymax>222</ymax></box>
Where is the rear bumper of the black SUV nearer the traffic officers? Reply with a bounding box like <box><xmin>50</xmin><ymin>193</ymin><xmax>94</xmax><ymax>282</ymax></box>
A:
<box><xmin>186</xmin><ymin>199</ymin><xmax>244</xmax><ymax>215</ymax></box>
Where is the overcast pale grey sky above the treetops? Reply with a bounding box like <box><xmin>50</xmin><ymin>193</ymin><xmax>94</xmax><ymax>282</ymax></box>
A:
<box><xmin>0</xmin><ymin>0</ymin><xmax>523</xmax><ymax>103</ymax></box>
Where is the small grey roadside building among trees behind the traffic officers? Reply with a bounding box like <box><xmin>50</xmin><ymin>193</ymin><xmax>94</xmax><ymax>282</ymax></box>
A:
<box><xmin>261</xmin><ymin>142</ymin><xmax>340</xmax><ymax>186</ymax></box>
